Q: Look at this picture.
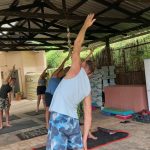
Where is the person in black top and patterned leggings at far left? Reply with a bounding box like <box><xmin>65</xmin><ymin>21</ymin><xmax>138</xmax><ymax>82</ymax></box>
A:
<box><xmin>0</xmin><ymin>66</ymin><xmax>16</xmax><ymax>129</ymax></box>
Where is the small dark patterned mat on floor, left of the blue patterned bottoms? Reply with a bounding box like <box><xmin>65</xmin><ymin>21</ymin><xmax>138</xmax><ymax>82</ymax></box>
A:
<box><xmin>16</xmin><ymin>127</ymin><xmax>47</xmax><ymax>140</ymax></box>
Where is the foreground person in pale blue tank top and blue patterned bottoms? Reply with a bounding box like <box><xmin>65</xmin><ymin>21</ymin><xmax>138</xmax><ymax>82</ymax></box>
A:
<box><xmin>46</xmin><ymin>14</ymin><xmax>95</xmax><ymax>150</ymax></box>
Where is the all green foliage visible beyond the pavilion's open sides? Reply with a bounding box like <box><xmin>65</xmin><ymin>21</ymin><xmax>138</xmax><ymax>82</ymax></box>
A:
<box><xmin>46</xmin><ymin>34</ymin><xmax>150</xmax><ymax>71</ymax></box>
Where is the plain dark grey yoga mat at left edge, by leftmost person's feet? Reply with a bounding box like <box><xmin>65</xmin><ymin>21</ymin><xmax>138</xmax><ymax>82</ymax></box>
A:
<box><xmin>0</xmin><ymin>120</ymin><xmax>40</xmax><ymax>135</ymax></box>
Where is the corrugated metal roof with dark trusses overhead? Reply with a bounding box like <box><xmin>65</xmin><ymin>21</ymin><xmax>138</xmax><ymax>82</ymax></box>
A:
<box><xmin>0</xmin><ymin>0</ymin><xmax>150</xmax><ymax>51</ymax></box>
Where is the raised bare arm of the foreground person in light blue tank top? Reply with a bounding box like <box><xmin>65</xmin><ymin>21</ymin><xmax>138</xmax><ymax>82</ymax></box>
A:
<box><xmin>68</xmin><ymin>14</ymin><xmax>95</xmax><ymax>76</ymax></box>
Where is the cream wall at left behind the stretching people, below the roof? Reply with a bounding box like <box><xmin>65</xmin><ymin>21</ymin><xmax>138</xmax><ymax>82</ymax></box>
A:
<box><xmin>0</xmin><ymin>51</ymin><xmax>46</xmax><ymax>97</ymax></box>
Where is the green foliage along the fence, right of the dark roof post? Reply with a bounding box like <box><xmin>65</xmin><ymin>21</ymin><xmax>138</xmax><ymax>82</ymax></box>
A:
<box><xmin>111</xmin><ymin>34</ymin><xmax>150</xmax><ymax>71</ymax></box>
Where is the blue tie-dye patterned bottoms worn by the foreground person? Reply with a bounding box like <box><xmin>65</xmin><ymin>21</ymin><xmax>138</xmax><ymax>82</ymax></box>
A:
<box><xmin>46</xmin><ymin>112</ymin><xmax>83</xmax><ymax>150</ymax></box>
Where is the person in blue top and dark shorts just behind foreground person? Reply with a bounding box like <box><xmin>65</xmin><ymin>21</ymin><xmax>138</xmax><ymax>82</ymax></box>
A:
<box><xmin>45</xmin><ymin>52</ymin><xmax>70</xmax><ymax>129</ymax></box>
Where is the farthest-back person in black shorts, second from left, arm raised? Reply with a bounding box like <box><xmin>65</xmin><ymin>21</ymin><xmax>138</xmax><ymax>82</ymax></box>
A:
<box><xmin>36</xmin><ymin>67</ymin><xmax>48</xmax><ymax>113</ymax></box>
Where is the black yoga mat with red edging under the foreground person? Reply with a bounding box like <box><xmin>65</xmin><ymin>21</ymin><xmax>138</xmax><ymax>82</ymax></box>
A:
<box><xmin>32</xmin><ymin>127</ymin><xmax>129</xmax><ymax>150</ymax></box>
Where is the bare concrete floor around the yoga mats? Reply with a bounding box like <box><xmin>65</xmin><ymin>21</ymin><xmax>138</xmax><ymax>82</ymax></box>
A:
<box><xmin>0</xmin><ymin>100</ymin><xmax>150</xmax><ymax>150</ymax></box>
